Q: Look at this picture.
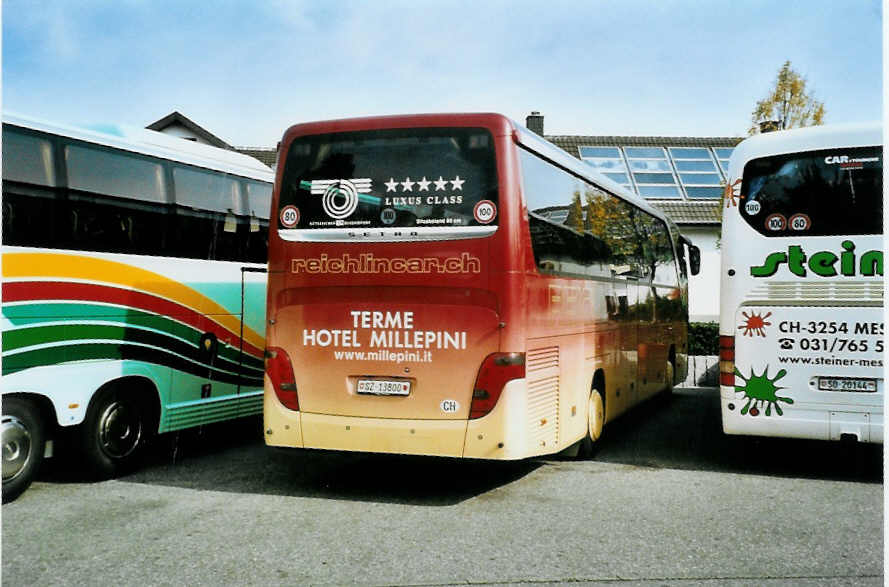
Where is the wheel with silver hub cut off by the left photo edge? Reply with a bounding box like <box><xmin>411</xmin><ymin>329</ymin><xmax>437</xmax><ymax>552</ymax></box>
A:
<box><xmin>3</xmin><ymin>397</ymin><xmax>46</xmax><ymax>503</ymax></box>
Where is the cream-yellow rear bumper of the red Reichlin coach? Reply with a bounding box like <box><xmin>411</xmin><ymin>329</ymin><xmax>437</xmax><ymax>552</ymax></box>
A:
<box><xmin>263</xmin><ymin>379</ymin><xmax>548</xmax><ymax>460</ymax></box>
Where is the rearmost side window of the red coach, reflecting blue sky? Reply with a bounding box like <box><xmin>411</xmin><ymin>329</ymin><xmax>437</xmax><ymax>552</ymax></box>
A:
<box><xmin>521</xmin><ymin>150</ymin><xmax>611</xmax><ymax>277</ymax></box>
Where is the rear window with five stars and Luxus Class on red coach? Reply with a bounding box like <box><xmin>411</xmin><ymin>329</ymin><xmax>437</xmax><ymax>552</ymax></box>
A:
<box><xmin>277</xmin><ymin>128</ymin><xmax>497</xmax><ymax>241</ymax></box>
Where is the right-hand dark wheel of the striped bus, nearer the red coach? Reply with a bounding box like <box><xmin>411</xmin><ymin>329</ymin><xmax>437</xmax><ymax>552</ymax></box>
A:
<box><xmin>81</xmin><ymin>385</ymin><xmax>148</xmax><ymax>478</ymax></box>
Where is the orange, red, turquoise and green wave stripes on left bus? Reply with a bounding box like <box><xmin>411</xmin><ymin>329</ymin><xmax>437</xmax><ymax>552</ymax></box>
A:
<box><xmin>2</xmin><ymin>253</ymin><xmax>264</xmax><ymax>388</ymax></box>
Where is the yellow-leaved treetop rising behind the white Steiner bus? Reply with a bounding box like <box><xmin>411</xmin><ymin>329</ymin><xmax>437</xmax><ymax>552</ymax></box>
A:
<box><xmin>748</xmin><ymin>61</ymin><xmax>824</xmax><ymax>135</ymax></box>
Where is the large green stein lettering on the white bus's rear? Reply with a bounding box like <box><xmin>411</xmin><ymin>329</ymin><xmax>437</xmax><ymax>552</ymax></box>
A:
<box><xmin>750</xmin><ymin>241</ymin><xmax>883</xmax><ymax>277</ymax></box>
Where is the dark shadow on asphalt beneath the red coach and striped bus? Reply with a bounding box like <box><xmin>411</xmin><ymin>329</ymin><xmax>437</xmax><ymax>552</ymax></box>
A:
<box><xmin>40</xmin><ymin>418</ymin><xmax>542</xmax><ymax>506</ymax></box>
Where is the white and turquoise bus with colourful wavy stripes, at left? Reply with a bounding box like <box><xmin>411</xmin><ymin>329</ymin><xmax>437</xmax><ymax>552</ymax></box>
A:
<box><xmin>0</xmin><ymin>115</ymin><xmax>273</xmax><ymax>501</ymax></box>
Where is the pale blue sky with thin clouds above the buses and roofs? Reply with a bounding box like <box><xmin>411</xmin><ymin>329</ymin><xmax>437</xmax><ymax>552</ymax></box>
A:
<box><xmin>2</xmin><ymin>0</ymin><xmax>883</xmax><ymax>147</ymax></box>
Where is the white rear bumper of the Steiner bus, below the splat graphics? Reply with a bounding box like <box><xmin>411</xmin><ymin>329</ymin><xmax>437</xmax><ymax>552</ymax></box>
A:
<box><xmin>720</xmin><ymin>386</ymin><xmax>883</xmax><ymax>444</ymax></box>
